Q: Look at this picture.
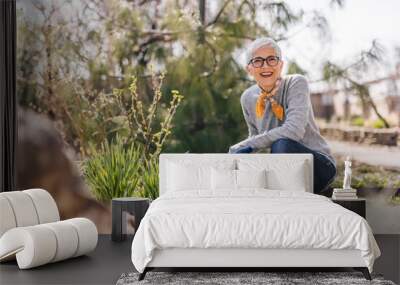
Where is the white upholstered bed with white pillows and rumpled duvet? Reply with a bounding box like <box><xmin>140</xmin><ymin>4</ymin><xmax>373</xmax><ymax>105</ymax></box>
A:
<box><xmin>132</xmin><ymin>154</ymin><xmax>380</xmax><ymax>279</ymax></box>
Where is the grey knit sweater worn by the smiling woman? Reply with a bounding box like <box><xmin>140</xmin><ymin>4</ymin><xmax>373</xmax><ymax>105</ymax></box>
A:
<box><xmin>229</xmin><ymin>74</ymin><xmax>336</xmax><ymax>166</ymax></box>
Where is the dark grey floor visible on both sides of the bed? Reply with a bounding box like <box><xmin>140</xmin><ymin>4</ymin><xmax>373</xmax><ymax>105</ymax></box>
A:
<box><xmin>0</xmin><ymin>235</ymin><xmax>400</xmax><ymax>285</ymax></box>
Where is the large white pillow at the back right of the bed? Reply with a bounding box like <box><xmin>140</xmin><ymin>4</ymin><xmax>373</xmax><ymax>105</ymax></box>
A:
<box><xmin>237</xmin><ymin>156</ymin><xmax>309</xmax><ymax>192</ymax></box>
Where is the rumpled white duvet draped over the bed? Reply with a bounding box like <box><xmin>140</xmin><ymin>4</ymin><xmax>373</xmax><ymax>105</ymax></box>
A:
<box><xmin>132</xmin><ymin>189</ymin><xmax>380</xmax><ymax>272</ymax></box>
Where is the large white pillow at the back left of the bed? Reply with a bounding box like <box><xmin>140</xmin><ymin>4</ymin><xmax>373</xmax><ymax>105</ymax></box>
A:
<box><xmin>166</xmin><ymin>159</ymin><xmax>235</xmax><ymax>191</ymax></box>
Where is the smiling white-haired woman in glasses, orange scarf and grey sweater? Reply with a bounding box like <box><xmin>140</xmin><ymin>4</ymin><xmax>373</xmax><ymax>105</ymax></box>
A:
<box><xmin>229</xmin><ymin>38</ymin><xmax>337</xmax><ymax>193</ymax></box>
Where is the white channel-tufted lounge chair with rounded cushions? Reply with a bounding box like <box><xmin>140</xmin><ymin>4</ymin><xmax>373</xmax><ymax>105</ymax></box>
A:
<box><xmin>0</xmin><ymin>189</ymin><xmax>98</xmax><ymax>269</ymax></box>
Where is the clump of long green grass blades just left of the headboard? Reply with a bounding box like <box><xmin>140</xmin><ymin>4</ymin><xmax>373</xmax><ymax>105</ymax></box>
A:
<box><xmin>83</xmin><ymin>135</ymin><xmax>159</xmax><ymax>201</ymax></box>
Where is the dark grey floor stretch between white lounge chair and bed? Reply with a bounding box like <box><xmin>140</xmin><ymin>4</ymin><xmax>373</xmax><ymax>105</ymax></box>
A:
<box><xmin>0</xmin><ymin>235</ymin><xmax>135</xmax><ymax>285</ymax></box>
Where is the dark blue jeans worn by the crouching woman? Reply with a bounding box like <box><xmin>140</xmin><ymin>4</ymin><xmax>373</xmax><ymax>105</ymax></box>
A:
<box><xmin>271</xmin><ymin>138</ymin><xmax>337</xmax><ymax>194</ymax></box>
